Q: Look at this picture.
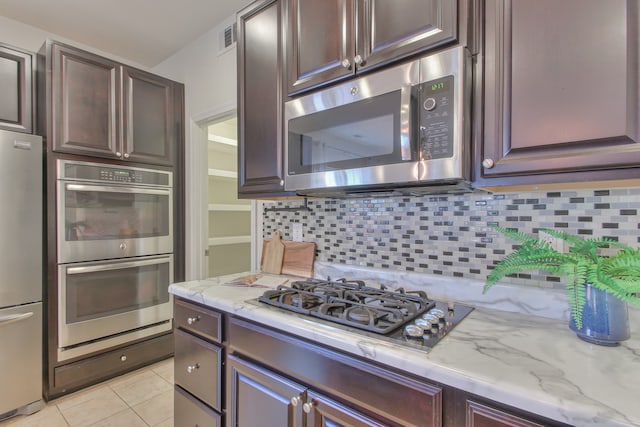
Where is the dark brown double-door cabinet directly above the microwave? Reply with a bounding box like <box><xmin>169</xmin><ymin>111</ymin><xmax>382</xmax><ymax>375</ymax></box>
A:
<box><xmin>286</xmin><ymin>0</ymin><xmax>458</xmax><ymax>95</ymax></box>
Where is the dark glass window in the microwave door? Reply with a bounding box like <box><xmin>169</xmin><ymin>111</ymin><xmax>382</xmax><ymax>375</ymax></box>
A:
<box><xmin>287</xmin><ymin>90</ymin><xmax>415</xmax><ymax>175</ymax></box>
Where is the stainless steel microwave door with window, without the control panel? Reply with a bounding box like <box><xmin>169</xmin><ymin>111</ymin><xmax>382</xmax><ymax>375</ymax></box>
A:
<box><xmin>285</xmin><ymin>56</ymin><xmax>419</xmax><ymax>191</ymax></box>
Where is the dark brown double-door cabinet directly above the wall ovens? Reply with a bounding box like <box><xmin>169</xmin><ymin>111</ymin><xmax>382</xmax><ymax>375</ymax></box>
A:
<box><xmin>47</xmin><ymin>42</ymin><xmax>176</xmax><ymax>165</ymax></box>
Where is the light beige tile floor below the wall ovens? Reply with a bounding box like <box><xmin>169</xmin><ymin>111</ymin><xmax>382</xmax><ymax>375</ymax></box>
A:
<box><xmin>0</xmin><ymin>358</ymin><xmax>173</xmax><ymax>427</ymax></box>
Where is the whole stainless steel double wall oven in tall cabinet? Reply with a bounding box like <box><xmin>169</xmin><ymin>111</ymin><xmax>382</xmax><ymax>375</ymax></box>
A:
<box><xmin>56</xmin><ymin>160</ymin><xmax>173</xmax><ymax>360</ymax></box>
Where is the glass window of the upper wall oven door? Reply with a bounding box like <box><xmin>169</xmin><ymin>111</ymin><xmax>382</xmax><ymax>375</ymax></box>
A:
<box><xmin>63</xmin><ymin>184</ymin><xmax>171</xmax><ymax>241</ymax></box>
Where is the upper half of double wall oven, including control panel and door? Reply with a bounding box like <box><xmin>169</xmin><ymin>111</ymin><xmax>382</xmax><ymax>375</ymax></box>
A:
<box><xmin>57</xmin><ymin>160</ymin><xmax>173</xmax><ymax>263</ymax></box>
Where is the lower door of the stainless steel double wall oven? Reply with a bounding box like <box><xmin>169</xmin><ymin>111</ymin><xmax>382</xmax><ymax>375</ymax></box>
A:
<box><xmin>58</xmin><ymin>255</ymin><xmax>173</xmax><ymax>347</ymax></box>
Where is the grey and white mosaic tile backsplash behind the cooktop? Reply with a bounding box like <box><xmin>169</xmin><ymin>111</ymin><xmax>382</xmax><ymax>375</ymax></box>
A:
<box><xmin>263</xmin><ymin>188</ymin><xmax>640</xmax><ymax>288</ymax></box>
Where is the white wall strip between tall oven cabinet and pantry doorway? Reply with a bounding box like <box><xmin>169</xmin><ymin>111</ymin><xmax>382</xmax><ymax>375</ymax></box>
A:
<box><xmin>152</xmin><ymin>16</ymin><xmax>236</xmax><ymax>280</ymax></box>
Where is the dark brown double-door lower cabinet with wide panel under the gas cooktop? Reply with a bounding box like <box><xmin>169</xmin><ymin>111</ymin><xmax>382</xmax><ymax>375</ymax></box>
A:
<box><xmin>226</xmin><ymin>317</ymin><xmax>442</xmax><ymax>427</ymax></box>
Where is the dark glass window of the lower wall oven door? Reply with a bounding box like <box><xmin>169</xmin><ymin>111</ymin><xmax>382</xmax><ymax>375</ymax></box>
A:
<box><xmin>65</xmin><ymin>262</ymin><xmax>171</xmax><ymax>324</ymax></box>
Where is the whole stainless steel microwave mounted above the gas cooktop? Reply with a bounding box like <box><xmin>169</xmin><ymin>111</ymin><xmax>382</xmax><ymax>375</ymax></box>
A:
<box><xmin>285</xmin><ymin>47</ymin><xmax>471</xmax><ymax>197</ymax></box>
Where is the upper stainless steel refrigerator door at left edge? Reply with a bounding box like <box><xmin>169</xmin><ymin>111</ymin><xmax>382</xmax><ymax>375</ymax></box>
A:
<box><xmin>0</xmin><ymin>131</ymin><xmax>43</xmax><ymax>308</ymax></box>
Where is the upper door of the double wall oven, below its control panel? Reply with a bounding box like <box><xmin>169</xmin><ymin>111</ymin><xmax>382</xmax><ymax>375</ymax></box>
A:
<box><xmin>57</xmin><ymin>180</ymin><xmax>173</xmax><ymax>264</ymax></box>
